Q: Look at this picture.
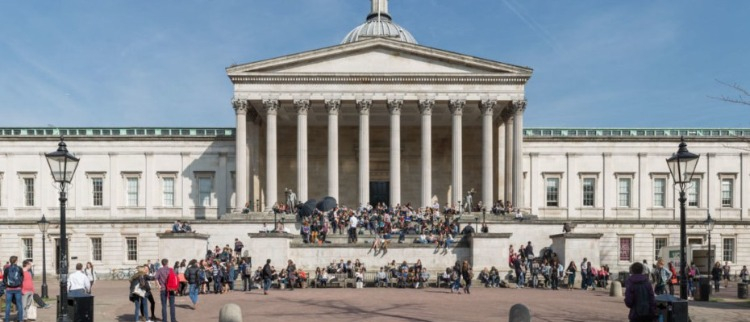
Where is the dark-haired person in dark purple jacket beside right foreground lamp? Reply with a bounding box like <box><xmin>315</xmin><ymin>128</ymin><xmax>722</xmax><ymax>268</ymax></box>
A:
<box><xmin>625</xmin><ymin>262</ymin><xmax>656</xmax><ymax>322</ymax></box>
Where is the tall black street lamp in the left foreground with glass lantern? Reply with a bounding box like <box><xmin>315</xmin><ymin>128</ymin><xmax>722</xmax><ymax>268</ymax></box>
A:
<box><xmin>44</xmin><ymin>136</ymin><xmax>79</xmax><ymax>322</ymax></box>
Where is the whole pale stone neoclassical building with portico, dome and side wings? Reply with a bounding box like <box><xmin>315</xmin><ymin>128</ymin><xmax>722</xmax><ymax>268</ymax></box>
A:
<box><xmin>0</xmin><ymin>0</ymin><xmax>750</xmax><ymax>276</ymax></box>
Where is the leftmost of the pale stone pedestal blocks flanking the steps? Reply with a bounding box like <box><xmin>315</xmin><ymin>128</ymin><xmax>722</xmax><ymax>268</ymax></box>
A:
<box><xmin>156</xmin><ymin>233</ymin><xmax>211</xmax><ymax>265</ymax></box>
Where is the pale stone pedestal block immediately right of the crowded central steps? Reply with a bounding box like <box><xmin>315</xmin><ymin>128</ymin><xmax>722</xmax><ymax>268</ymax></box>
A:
<box><xmin>471</xmin><ymin>233</ymin><xmax>513</xmax><ymax>272</ymax></box>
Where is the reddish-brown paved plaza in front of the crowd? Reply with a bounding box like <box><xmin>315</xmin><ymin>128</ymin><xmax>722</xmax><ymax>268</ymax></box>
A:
<box><xmin>25</xmin><ymin>281</ymin><xmax>750</xmax><ymax>322</ymax></box>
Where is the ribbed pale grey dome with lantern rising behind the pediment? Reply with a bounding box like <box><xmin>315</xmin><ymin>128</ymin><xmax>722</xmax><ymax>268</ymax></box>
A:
<box><xmin>341</xmin><ymin>0</ymin><xmax>417</xmax><ymax>44</ymax></box>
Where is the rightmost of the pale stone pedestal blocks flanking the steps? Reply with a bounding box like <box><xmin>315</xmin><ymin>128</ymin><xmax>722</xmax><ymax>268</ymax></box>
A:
<box><xmin>549</xmin><ymin>233</ymin><xmax>603</xmax><ymax>268</ymax></box>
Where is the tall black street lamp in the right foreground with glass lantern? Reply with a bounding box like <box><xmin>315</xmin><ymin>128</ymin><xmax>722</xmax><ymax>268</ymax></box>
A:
<box><xmin>667</xmin><ymin>137</ymin><xmax>700</xmax><ymax>300</ymax></box>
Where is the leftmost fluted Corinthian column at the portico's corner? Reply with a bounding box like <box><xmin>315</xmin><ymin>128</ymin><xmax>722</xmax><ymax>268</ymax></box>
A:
<box><xmin>232</xmin><ymin>99</ymin><xmax>249</xmax><ymax>211</ymax></box>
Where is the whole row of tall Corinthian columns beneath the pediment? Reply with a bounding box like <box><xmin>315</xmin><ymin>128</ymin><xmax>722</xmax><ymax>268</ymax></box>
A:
<box><xmin>233</xmin><ymin>99</ymin><xmax>526</xmax><ymax>210</ymax></box>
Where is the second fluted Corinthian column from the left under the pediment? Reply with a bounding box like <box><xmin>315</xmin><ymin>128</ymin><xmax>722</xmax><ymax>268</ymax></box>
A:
<box><xmin>263</xmin><ymin>100</ymin><xmax>279</xmax><ymax>211</ymax></box>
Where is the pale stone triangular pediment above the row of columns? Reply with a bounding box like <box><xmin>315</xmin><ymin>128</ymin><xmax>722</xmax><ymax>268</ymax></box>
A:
<box><xmin>227</xmin><ymin>38</ymin><xmax>532</xmax><ymax>76</ymax></box>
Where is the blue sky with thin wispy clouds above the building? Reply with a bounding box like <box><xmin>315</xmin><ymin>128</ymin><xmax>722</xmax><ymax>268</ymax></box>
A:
<box><xmin>0</xmin><ymin>0</ymin><xmax>750</xmax><ymax>127</ymax></box>
